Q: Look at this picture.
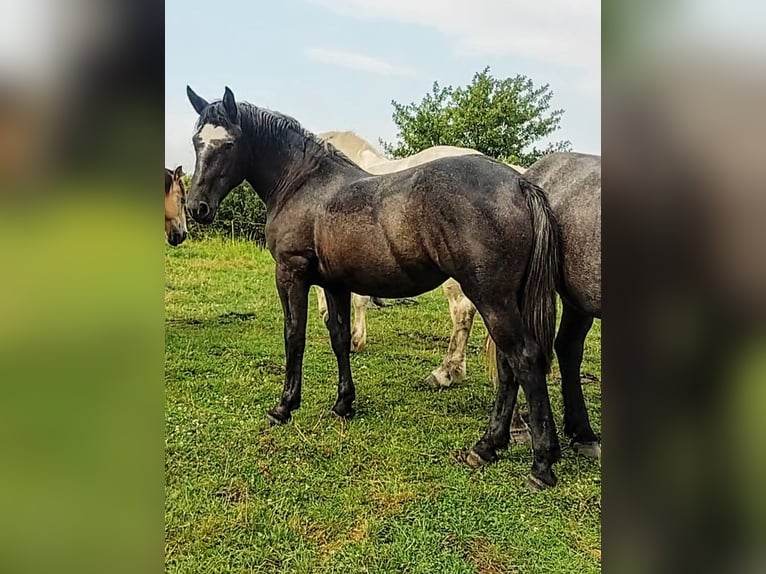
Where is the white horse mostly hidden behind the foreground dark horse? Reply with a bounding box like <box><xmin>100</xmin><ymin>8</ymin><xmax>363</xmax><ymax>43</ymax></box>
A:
<box><xmin>317</xmin><ymin>131</ymin><xmax>526</xmax><ymax>387</ymax></box>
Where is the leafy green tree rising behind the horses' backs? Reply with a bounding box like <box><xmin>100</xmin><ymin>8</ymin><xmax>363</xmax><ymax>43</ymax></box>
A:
<box><xmin>380</xmin><ymin>67</ymin><xmax>572</xmax><ymax>166</ymax></box>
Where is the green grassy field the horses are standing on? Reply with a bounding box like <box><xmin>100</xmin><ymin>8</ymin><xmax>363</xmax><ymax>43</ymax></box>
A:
<box><xmin>165</xmin><ymin>240</ymin><xmax>601</xmax><ymax>574</ymax></box>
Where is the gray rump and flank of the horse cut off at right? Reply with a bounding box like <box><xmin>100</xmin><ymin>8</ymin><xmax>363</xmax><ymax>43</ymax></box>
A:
<box><xmin>524</xmin><ymin>152</ymin><xmax>601</xmax><ymax>317</ymax></box>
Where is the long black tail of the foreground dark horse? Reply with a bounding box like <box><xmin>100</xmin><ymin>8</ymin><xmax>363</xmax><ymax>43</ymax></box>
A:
<box><xmin>485</xmin><ymin>177</ymin><xmax>561</xmax><ymax>384</ymax></box>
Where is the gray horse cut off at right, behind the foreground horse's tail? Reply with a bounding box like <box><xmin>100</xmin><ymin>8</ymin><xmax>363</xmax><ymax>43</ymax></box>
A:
<box><xmin>487</xmin><ymin>152</ymin><xmax>601</xmax><ymax>458</ymax></box>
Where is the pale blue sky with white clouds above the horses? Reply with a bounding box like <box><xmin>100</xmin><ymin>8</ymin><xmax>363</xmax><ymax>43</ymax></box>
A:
<box><xmin>165</xmin><ymin>0</ymin><xmax>601</xmax><ymax>173</ymax></box>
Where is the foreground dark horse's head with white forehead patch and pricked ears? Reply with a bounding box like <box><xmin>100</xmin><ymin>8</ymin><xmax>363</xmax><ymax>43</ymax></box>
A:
<box><xmin>186</xmin><ymin>86</ymin><xmax>247</xmax><ymax>223</ymax></box>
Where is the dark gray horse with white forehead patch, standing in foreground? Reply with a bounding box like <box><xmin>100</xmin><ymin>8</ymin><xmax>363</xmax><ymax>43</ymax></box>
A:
<box><xmin>187</xmin><ymin>88</ymin><xmax>560</xmax><ymax>488</ymax></box>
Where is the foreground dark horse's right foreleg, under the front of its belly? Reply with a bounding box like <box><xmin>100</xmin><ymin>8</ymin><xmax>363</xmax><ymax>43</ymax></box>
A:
<box><xmin>327</xmin><ymin>290</ymin><xmax>356</xmax><ymax>419</ymax></box>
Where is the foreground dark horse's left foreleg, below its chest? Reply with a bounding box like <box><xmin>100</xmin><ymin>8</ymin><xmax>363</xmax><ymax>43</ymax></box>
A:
<box><xmin>266</xmin><ymin>266</ymin><xmax>309</xmax><ymax>424</ymax></box>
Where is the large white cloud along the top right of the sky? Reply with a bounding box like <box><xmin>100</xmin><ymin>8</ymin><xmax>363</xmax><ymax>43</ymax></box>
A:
<box><xmin>311</xmin><ymin>0</ymin><xmax>601</xmax><ymax>75</ymax></box>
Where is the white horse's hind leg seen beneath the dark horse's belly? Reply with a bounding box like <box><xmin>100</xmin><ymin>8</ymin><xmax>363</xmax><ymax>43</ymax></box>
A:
<box><xmin>426</xmin><ymin>279</ymin><xmax>476</xmax><ymax>388</ymax></box>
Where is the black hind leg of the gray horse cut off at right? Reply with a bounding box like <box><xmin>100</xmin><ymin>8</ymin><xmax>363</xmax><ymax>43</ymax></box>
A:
<box><xmin>555</xmin><ymin>302</ymin><xmax>601</xmax><ymax>458</ymax></box>
